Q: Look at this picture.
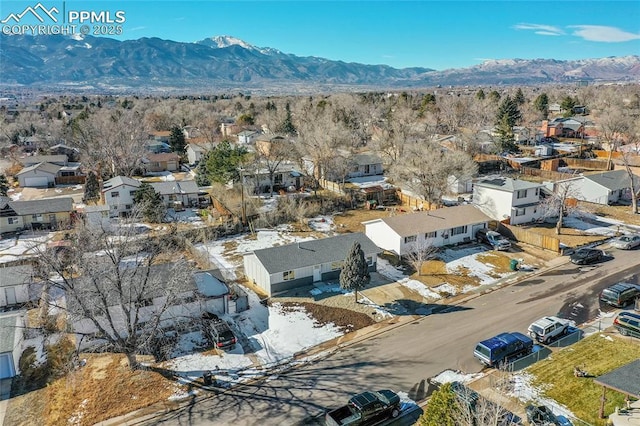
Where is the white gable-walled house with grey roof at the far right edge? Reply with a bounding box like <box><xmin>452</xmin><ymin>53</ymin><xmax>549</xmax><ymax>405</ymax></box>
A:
<box><xmin>557</xmin><ymin>170</ymin><xmax>640</xmax><ymax>204</ymax></box>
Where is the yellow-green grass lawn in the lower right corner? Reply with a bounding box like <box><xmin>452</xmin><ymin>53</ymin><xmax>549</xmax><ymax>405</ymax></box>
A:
<box><xmin>527</xmin><ymin>333</ymin><xmax>640</xmax><ymax>425</ymax></box>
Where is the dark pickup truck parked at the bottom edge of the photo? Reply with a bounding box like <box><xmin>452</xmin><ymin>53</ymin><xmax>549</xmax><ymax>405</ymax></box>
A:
<box><xmin>325</xmin><ymin>389</ymin><xmax>400</xmax><ymax>426</ymax></box>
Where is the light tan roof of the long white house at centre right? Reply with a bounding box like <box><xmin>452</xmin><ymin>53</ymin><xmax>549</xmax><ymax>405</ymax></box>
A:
<box><xmin>365</xmin><ymin>204</ymin><xmax>491</xmax><ymax>237</ymax></box>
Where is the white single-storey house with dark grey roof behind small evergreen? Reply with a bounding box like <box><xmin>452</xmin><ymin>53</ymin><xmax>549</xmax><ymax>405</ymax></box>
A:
<box><xmin>244</xmin><ymin>233</ymin><xmax>382</xmax><ymax>296</ymax></box>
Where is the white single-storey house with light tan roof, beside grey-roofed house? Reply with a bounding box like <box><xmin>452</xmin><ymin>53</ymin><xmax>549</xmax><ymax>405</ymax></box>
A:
<box><xmin>362</xmin><ymin>204</ymin><xmax>491</xmax><ymax>256</ymax></box>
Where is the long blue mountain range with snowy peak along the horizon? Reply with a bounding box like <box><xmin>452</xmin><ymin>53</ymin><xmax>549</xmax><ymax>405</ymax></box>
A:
<box><xmin>0</xmin><ymin>35</ymin><xmax>640</xmax><ymax>93</ymax></box>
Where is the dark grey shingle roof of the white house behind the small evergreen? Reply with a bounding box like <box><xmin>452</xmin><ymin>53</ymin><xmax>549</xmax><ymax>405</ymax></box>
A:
<box><xmin>253</xmin><ymin>232</ymin><xmax>382</xmax><ymax>274</ymax></box>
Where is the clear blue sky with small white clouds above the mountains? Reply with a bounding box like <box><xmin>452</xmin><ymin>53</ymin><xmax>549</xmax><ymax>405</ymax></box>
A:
<box><xmin>0</xmin><ymin>0</ymin><xmax>640</xmax><ymax>70</ymax></box>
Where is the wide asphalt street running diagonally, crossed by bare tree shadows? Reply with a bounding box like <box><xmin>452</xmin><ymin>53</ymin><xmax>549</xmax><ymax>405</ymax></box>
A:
<box><xmin>141</xmin><ymin>246</ymin><xmax>640</xmax><ymax>426</ymax></box>
